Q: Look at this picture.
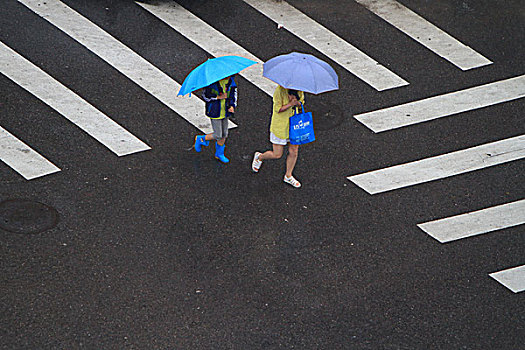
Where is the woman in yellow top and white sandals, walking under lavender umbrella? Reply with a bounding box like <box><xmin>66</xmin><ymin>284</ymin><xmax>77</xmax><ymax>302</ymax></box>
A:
<box><xmin>252</xmin><ymin>85</ymin><xmax>304</xmax><ymax>188</ymax></box>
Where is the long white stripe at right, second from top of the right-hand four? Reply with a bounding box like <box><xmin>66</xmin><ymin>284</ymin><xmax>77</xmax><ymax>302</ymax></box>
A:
<box><xmin>348</xmin><ymin>135</ymin><xmax>525</xmax><ymax>194</ymax></box>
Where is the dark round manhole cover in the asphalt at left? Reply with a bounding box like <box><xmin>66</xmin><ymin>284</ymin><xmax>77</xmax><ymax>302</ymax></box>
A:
<box><xmin>0</xmin><ymin>199</ymin><xmax>58</xmax><ymax>234</ymax></box>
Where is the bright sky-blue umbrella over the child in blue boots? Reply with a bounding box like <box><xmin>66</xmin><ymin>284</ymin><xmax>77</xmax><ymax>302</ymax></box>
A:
<box><xmin>177</xmin><ymin>56</ymin><xmax>257</xmax><ymax>96</ymax></box>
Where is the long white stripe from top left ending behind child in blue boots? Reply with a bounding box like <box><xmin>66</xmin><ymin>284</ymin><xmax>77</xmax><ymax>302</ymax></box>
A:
<box><xmin>18</xmin><ymin>0</ymin><xmax>231</xmax><ymax>133</ymax></box>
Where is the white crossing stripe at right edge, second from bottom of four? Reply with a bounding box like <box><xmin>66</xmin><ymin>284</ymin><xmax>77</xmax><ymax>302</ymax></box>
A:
<box><xmin>417</xmin><ymin>199</ymin><xmax>525</xmax><ymax>243</ymax></box>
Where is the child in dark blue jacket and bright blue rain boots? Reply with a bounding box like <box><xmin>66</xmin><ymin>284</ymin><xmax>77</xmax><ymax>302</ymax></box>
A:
<box><xmin>194</xmin><ymin>76</ymin><xmax>237</xmax><ymax>163</ymax></box>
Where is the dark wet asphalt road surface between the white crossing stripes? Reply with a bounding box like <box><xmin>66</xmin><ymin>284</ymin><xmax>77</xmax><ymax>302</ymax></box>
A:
<box><xmin>0</xmin><ymin>0</ymin><xmax>525</xmax><ymax>349</ymax></box>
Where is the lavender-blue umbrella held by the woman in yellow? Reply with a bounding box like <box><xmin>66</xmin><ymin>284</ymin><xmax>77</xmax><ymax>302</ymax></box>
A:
<box><xmin>263</xmin><ymin>52</ymin><xmax>339</xmax><ymax>94</ymax></box>
